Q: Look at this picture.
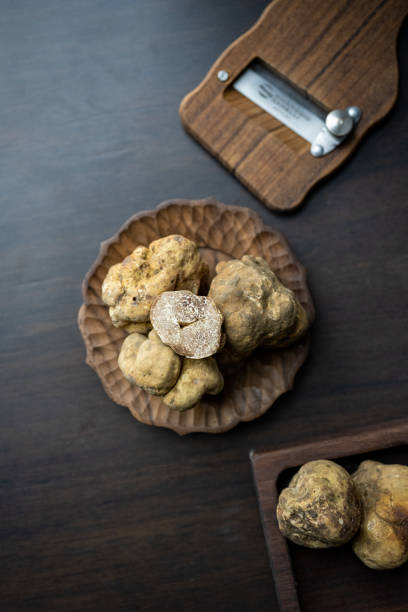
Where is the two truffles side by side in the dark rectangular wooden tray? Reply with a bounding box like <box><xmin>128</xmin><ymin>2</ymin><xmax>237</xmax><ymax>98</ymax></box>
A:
<box><xmin>276</xmin><ymin>460</ymin><xmax>408</xmax><ymax>569</ymax></box>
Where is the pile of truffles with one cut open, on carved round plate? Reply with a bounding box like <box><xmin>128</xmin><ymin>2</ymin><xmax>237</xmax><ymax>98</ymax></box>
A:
<box><xmin>102</xmin><ymin>235</ymin><xmax>308</xmax><ymax>411</ymax></box>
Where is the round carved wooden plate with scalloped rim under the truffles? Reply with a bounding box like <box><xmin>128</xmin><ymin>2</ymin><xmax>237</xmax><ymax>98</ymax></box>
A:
<box><xmin>78</xmin><ymin>199</ymin><xmax>314</xmax><ymax>434</ymax></box>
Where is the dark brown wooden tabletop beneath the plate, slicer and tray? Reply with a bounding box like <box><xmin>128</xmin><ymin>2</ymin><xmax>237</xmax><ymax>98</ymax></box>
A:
<box><xmin>0</xmin><ymin>0</ymin><xmax>408</xmax><ymax>612</ymax></box>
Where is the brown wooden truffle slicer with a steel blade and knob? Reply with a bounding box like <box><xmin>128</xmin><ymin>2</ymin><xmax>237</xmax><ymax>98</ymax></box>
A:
<box><xmin>180</xmin><ymin>0</ymin><xmax>408</xmax><ymax>210</ymax></box>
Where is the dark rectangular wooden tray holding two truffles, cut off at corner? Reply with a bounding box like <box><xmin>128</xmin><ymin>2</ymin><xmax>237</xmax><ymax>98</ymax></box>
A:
<box><xmin>250</xmin><ymin>421</ymin><xmax>408</xmax><ymax>612</ymax></box>
